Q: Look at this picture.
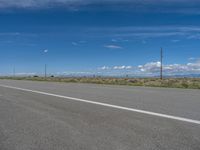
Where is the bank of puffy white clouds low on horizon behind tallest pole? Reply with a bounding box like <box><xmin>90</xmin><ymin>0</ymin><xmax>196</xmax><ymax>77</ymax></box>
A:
<box><xmin>97</xmin><ymin>60</ymin><xmax>200</xmax><ymax>76</ymax></box>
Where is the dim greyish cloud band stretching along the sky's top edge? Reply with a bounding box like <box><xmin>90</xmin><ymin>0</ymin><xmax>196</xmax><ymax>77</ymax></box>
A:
<box><xmin>0</xmin><ymin>0</ymin><xmax>200</xmax><ymax>13</ymax></box>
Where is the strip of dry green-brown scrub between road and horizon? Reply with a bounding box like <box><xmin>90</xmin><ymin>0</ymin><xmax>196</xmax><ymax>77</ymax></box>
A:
<box><xmin>0</xmin><ymin>77</ymin><xmax>200</xmax><ymax>89</ymax></box>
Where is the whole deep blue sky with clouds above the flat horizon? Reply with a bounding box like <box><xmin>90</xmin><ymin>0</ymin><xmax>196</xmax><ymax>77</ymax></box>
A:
<box><xmin>0</xmin><ymin>0</ymin><xmax>200</xmax><ymax>76</ymax></box>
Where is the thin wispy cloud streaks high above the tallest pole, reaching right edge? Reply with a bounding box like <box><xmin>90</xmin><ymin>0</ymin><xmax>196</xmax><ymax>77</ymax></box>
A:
<box><xmin>88</xmin><ymin>26</ymin><xmax>200</xmax><ymax>39</ymax></box>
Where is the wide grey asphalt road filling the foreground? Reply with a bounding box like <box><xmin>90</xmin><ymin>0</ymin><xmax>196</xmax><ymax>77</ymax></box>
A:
<box><xmin>0</xmin><ymin>80</ymin><xmax>200</xmax><ymax>150</ymax></box>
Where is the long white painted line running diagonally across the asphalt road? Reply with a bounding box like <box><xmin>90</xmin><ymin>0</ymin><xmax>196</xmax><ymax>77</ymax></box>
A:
<box><xmin>0</xmin><ymin>84</ymin><xmax>200</xmax><ymax>125</ymax></box>
